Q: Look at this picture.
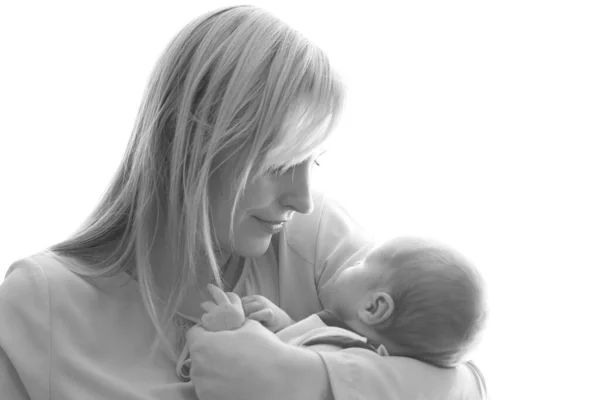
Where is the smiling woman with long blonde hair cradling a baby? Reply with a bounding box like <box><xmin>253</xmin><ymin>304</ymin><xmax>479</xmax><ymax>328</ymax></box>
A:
<box><xmin>0</xmin><ymin>6</ymin><xmax>483</xmax><ymax>400</ymax></box>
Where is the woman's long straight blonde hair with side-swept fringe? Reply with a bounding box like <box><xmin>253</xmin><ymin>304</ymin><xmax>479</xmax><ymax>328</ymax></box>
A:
<box><xmin>50</xmin><ymin>6</ymin><xmax>344</xmax><ymax>358</ymax></box>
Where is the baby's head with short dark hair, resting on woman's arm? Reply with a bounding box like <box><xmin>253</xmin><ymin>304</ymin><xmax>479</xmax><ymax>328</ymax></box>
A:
<box><xmin>331</xmin><ymin>238</ymin><xmax>486</xmax><ymax>367</ymax></box>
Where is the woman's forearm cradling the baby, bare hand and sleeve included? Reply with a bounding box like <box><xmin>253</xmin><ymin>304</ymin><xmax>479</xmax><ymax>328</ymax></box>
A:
<box><xmin>187</xmin><ymin>321</ymin><xmax>485</xmax><ymax>400</ymax></box>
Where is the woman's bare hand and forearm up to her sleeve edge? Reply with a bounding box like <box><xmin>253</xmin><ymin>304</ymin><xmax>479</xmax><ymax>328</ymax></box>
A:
<box><xmin>187</xmin><ymin>320</ymin><xmax>332</xmax><ymax>400</ymax></box>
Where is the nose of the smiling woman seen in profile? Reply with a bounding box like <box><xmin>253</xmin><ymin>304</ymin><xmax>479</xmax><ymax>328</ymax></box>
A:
<box><xmin>281</xmin><ymin>162</ymin><xmax>314</xmax><ymax>214</ymax></box>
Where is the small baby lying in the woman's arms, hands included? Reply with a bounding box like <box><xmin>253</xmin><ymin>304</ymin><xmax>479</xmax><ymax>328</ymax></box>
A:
<box><xmin>202</xmin><ymin>238</ymin><xmax>486</xmax><ymax>368</ymax></box>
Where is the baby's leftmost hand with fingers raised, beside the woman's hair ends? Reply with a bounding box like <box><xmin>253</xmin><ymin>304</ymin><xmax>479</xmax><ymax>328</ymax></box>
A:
<box><xmin>200</xmin><ymin>284</ymin><xmax>246</xmax><ymax>332</ymax></box>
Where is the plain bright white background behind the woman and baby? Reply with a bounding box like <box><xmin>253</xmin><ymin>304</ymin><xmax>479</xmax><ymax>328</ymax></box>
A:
<box><xmin>0</xmin><ymin>0</ymin><xmax>600</xmax><ymax>399</ymax></box>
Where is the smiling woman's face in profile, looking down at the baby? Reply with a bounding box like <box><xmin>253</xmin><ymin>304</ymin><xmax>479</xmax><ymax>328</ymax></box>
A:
<box><xmin>211</xmin><ymin>156</ymin><xmax>313</xmax><ymax>257</ymax></box>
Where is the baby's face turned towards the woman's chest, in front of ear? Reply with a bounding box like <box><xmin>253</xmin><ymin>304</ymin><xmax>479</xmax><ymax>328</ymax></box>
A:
<box><xmin>330</xmin><ymin>252</ymin><xmax>388</xmax><ymax>319</ymax></box>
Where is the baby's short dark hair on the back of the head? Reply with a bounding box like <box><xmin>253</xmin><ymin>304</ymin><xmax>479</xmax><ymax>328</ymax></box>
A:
<box><xmin>374</xmin><ymin>238</ymin><xmax>487</xmax><ymax>368</ymax></box>
